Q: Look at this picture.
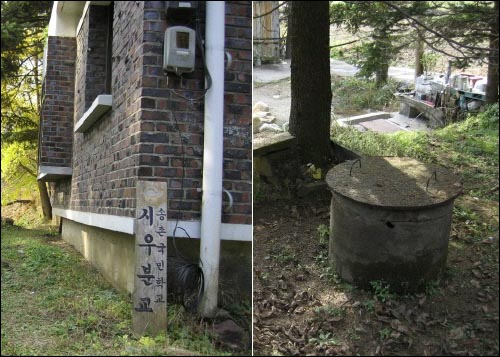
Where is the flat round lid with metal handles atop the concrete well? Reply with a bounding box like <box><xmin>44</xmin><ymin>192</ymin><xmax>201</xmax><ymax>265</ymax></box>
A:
<box><xmin>326</xmin><ymin>157</ymin><xmax>462</xmax><ymax>208</ymax></box>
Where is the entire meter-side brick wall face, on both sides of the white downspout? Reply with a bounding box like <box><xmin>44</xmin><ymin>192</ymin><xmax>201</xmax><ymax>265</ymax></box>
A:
<box><xmin>139</xmin><ymin>1</ymin><xmax>252</xmax><ymax>224</ymax></box>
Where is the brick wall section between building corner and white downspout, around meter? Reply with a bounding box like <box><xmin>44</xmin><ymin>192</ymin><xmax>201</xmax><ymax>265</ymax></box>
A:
<box><xmin>139</xmin><ymin>1</ymin><xmax>205</xmax><ymax>220</ymax></box>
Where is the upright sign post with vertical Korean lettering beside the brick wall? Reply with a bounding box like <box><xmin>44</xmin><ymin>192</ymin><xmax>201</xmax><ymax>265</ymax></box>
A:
<box><xmin>132</xmin><ymin>181</ymin><xmax>167</xmax><ymax>336</ymax></box>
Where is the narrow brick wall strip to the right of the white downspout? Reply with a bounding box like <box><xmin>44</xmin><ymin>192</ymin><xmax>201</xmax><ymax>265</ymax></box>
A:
<box><xmin>222</xmin><ymin>1</ymin><xmax>252</xmax><ymax>224</ymax></box>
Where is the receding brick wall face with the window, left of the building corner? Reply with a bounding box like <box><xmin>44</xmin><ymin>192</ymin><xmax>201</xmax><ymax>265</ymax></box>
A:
<box><xmin>55</xmin><ymin>1</ymin><xmax>143</xmax><ymax>217</ymax></box>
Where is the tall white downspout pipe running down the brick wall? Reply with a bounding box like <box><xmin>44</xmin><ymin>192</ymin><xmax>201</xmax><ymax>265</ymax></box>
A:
<box><xmin>200</xmin><ymin>1</ymin><xmax>225</xmax><ymax>317</ymax></box>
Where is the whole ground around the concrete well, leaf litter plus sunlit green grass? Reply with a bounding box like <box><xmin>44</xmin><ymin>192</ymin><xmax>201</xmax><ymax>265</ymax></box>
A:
<box><xmin>253</xmin><ymin>106</ymin><xmax>499</xmax><ymax>356</ymax></box>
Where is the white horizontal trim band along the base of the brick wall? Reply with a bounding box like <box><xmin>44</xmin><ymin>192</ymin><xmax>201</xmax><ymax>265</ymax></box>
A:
<box><xmin>52</xmin><ymin>207</ymin><xmax>252</xmax><ymax>242</ymax></box>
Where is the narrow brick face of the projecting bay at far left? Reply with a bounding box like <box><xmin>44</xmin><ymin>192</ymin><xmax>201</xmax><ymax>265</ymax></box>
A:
<box><xmin>39</xmin><ymin>36</ymin><xmax>76</xmax><ymax>167</ymax></box>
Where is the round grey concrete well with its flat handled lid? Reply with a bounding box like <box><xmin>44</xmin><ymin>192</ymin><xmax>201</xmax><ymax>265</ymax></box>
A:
<box><xmin>327</xmin><ymin>157</ymin><xmax>462</xmax><ymax>291</ymax></box>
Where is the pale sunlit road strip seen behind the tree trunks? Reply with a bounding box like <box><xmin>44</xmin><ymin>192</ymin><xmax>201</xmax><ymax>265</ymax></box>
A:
<box><xmin>253</xmin><ymin>59</ymin><xmax>415</xmax><ymax>82</ymax></box>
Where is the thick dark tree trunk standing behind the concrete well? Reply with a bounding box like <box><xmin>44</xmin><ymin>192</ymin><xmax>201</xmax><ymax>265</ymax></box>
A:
<box><xmin>290</xmin><ymin>1</ymin><xmax>332</xmax><ymax>168</ymax></box>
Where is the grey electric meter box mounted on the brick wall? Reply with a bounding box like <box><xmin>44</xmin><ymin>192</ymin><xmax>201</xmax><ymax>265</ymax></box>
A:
<box><xmin>163</xmin><ymin>26</ymin><xmax>196</xmax><ymax>75</ymax></box>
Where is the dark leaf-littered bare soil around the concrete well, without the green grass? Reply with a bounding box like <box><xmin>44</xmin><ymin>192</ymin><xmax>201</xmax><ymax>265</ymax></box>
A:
<box><xmin>253</xmin><ymin>192</ymin><xmax>499</xmax><ymax>356</ymax></box>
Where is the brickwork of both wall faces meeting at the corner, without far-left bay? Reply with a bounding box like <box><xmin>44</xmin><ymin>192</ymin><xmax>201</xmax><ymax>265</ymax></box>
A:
<box><xmin>50</xmin><ymin>1</ymin><xmax>252</xmax><ymax>224</ymax></box>
